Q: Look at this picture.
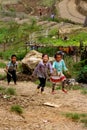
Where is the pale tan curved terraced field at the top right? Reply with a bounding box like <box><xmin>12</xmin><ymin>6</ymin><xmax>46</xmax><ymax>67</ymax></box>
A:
<box><xmin>57</xmin><ymin>0</ymin><xmax>85</xmax><ymax>23</ymax></box>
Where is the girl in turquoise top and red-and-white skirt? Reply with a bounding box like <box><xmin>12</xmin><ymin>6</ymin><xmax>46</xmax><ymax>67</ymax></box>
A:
<box><xmin>51</xmin><ymin>52</ymin><xmax>68</xmax><ymax>94</ymax></box>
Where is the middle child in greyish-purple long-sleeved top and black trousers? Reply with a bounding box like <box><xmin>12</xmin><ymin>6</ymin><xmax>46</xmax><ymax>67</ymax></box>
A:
<box><xmin>33</xmin><ymin>54</ymin><xmax>52</xmax><ymax>93</ymax></box>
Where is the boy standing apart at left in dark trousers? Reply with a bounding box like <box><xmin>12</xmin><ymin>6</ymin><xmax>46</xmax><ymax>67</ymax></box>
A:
<box><xmin>6</xmin><ymin>55</ymin><xmax>17</xmax><ymax>85</ymax></box>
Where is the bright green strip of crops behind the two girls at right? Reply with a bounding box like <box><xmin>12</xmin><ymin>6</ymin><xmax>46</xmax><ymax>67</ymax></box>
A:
<box><xmin>38</xmin><ymin>30</ymin><xmax>87</xmax><ymax>46</ymax></box>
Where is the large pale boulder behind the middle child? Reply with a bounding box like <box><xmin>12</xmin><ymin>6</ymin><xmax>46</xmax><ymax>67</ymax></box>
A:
<box><xmin>22</xmin><ymin>50</ymin><xmax>54</xmax><ymax>75</ymax></box>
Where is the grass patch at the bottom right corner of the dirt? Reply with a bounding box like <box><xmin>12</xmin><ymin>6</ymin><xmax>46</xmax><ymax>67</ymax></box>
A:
<box><xmin>63</xmin><ymin>112</ymin><xmax>87</xmax><ymax>127</ymax></box>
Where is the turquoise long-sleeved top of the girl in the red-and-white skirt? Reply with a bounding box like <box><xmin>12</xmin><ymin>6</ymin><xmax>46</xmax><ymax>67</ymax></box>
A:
<box><xmin>53</xmin><ymin>59</ymin><xmax>68</xmax><ymax>73</ymax></box>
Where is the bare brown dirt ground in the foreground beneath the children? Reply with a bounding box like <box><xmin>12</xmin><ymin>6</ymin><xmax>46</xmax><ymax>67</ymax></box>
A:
<box><xmin>0</xmin><ymin>81</ymin><xmax>87</xmax><ymax>130</ymax></box>
